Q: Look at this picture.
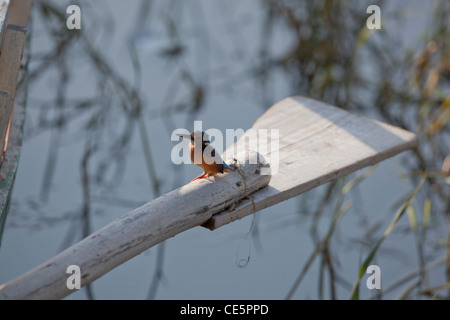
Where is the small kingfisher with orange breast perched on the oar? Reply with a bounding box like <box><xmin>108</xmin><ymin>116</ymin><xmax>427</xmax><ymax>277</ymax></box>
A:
<box><xmin>177</xmin><ymin>131</ymin><xmax>234</xmax><ymax>181</ymax></box>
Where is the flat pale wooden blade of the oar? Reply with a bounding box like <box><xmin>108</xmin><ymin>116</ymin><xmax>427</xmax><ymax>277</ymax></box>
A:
<box><xmin>205</xmin><ymin>97</ymin><xmax>416</xmax><ymax>229</ymax></box>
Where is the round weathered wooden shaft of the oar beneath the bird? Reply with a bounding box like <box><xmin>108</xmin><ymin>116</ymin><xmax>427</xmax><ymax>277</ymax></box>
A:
<box><xmin>0</xmin><ymin>152</ymin><xmax>270</xmax><ymax>299</ymax></box>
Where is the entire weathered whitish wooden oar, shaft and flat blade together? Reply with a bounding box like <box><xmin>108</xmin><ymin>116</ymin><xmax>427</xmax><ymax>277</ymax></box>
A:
<box><xmin>0</xmin><ymin>97</ymin><xmax>416</xmax><ymax>299</ymax></box>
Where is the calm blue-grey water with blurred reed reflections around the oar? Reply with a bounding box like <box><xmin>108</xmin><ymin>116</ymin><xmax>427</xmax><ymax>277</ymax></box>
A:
<box><xmin>0</xmin><ymin>0</ymin><xmax>450</xmax><ymax>299</ymax></box>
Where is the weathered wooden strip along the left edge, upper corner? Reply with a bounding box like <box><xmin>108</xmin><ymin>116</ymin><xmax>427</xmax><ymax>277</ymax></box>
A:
<box><xmin>0</xmin><ymin>0</ymin><xmax>32</xmax><ymax>243</ymax></box>
